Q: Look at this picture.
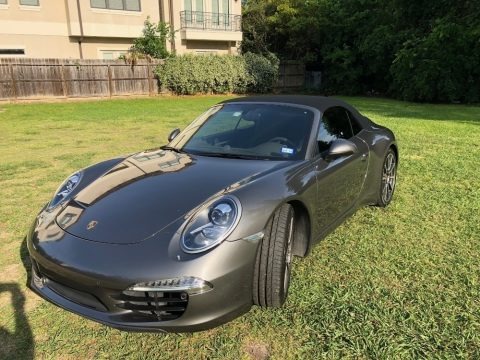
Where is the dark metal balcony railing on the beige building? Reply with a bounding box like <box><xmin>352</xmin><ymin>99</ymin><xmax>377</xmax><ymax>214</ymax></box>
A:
<box><xmin>180</xmin><ymin>10</ymin><xmax>242</xmax><ymax>31</ymax></box>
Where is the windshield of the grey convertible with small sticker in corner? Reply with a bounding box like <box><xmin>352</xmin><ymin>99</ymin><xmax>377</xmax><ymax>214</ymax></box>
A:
<box><xmin>170</xmin><ymin>103</ymin><xmax>314</xmax><ymax>160</ymax></box>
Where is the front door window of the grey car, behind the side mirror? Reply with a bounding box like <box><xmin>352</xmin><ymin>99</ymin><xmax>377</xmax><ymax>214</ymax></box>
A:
<box><xmin>317</xmin><ymin>107</ymin><xmax>353</xmax><ymax>152</ymax></box>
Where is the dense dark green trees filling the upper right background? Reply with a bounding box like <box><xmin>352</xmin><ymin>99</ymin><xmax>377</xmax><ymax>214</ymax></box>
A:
<box><xmin>242</xmin><ymin>0</ymin><xmax>480</xmax><ymax>102</ymax></box>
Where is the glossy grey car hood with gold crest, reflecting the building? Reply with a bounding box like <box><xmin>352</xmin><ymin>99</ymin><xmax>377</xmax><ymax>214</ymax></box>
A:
<box><xmin>57</xmin><ymin>150</ymin><xmax>290</xmax><ymax>244</ymax></box>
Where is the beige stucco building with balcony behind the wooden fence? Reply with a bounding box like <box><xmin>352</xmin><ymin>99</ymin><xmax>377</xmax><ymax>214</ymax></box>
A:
<box><xmin>0</xmin><ymin>0</ymin><xmax>242</xmax><ymax>59</ymax></box>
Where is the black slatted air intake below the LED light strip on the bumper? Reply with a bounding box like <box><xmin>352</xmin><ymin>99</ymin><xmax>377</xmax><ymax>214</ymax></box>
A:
<box><xmin>112</xmin><ymin>290</ymin><xmax>188</xmax><ymax>321</ymax></box>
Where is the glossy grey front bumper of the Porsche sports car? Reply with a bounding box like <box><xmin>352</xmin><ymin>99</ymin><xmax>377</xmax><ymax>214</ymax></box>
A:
<box><xmin>27</xmin><ymin>224</ymin><xmax>257</xmax><ymax>332</ymax></box>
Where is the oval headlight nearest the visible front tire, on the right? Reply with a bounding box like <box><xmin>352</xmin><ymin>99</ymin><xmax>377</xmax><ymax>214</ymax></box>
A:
<box><xmin>181</xmin><ymin>195</ymin><xmax>241</xmax><ymax>253</ymax></box>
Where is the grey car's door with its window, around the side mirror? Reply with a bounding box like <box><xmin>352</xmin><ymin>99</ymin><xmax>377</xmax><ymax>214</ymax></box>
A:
<box><xmin>315</xmin><ymin>107</ymin><xmax>368</xmax><ymax>230</ymax></box>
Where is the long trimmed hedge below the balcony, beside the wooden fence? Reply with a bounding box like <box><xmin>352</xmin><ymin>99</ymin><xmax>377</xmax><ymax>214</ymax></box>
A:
<box><xmin>156</xmin><ymin>54</ymin><xmax>277</xmax><ymax>95</ymax></box>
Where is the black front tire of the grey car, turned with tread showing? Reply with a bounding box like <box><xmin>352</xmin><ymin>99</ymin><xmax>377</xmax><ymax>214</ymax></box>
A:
<box><xmin>253</xmin><ymin>204</ymin><xmax>295</xmax><ymax>307</ymax></box>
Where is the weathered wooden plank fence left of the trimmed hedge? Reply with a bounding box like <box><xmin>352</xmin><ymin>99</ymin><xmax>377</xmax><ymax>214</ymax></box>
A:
<box><xmin>0</xmin><ymin>58</ymin><xmax>159</xmax><ymax>100</ymax></box>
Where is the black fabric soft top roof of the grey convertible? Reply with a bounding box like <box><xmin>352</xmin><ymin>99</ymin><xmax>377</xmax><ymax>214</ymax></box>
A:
<box><xmin>222</xmin><ymin>95</ymin><xmax>376</xmax><ymax>129</ymax></box>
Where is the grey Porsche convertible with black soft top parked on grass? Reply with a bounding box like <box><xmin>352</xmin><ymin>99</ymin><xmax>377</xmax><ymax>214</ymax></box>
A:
<box><xmin>27</xmin><ymin>96</ymin><xmax>398</xmax><ymax>332</ymax></box>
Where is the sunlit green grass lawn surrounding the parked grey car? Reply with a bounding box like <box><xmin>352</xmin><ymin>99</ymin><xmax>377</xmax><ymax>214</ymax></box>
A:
<box><xmin>0</xmin><ymin>97</ymin><xmax>480</xmax><ymax>359</ymax></box>
